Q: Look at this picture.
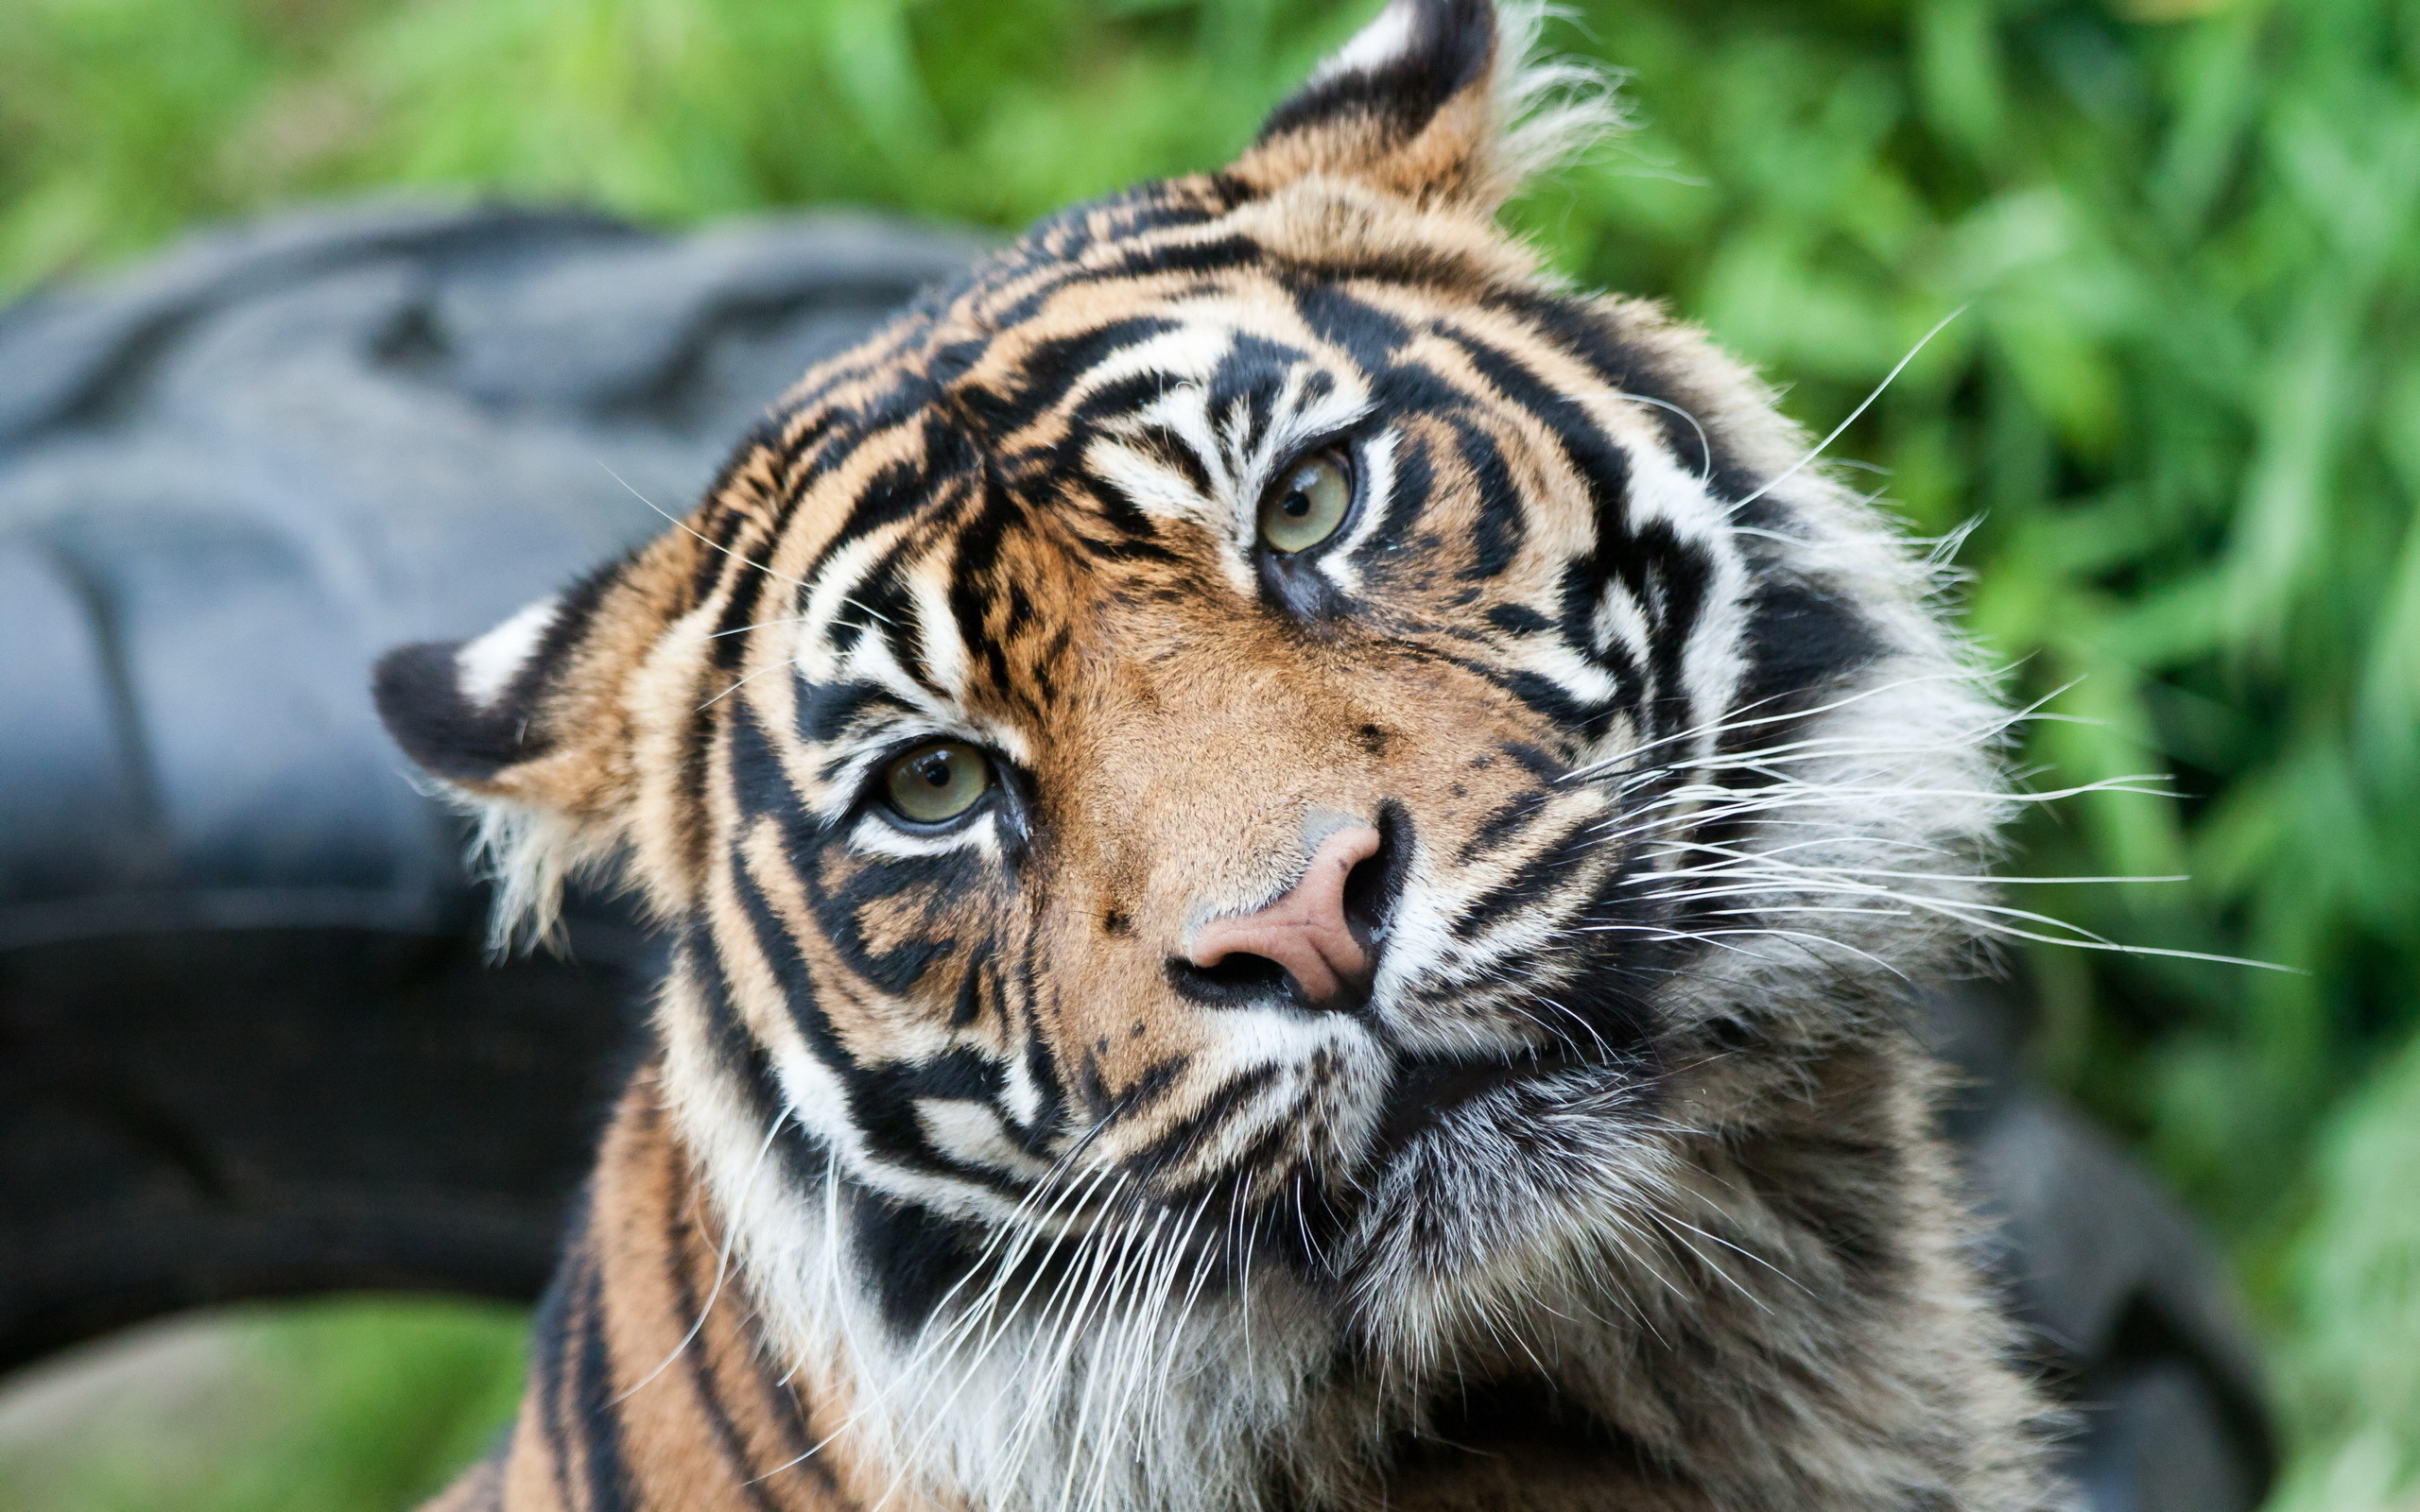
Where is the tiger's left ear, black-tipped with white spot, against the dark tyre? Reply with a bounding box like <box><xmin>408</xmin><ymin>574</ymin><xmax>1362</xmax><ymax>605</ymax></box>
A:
<box><xmin>372</xmin><ymin>554</ymin><xmax>666</xmax><ymax>946</ymax></box>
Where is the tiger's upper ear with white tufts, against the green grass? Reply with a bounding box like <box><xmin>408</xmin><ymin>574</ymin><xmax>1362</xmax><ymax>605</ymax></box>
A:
<box><xmin>1229</xmin><ymin>0</ymin><xmax>1619</xmax><ymax>215</ymax></box>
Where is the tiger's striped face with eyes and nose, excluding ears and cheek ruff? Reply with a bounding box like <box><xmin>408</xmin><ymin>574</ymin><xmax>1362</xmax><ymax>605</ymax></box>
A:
<box><xmin>690</xmin><ymin>233</ymin><xmax>1747</xmax><ymax>1244</ymax></box>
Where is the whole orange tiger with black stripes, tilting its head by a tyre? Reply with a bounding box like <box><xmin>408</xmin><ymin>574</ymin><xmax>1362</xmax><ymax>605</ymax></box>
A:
<box><xmin>375</xmin><ymin>0</ymin><xmax>2071</xmax><ymax>1512</ymax></box>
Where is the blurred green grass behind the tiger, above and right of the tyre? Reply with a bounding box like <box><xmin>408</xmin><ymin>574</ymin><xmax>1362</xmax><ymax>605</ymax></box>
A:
<box><xmin>0</xmin><ymin>0</ymin><xmax>2420</xmax><ymax>1509</ymax></box>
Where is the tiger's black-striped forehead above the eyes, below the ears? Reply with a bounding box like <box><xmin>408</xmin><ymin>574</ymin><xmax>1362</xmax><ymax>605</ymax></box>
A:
<box><xmin>782</xmin><ymin>209</ymin><xmax>1578</xmax><ymax>524</ymax></box>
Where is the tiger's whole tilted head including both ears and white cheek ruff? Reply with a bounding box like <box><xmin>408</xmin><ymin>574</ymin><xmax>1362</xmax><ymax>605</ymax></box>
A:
<box><xmin>380</xmin><ymin>0</ymin><xmax>1994</xmax><ymax>1461</ymax></box>
